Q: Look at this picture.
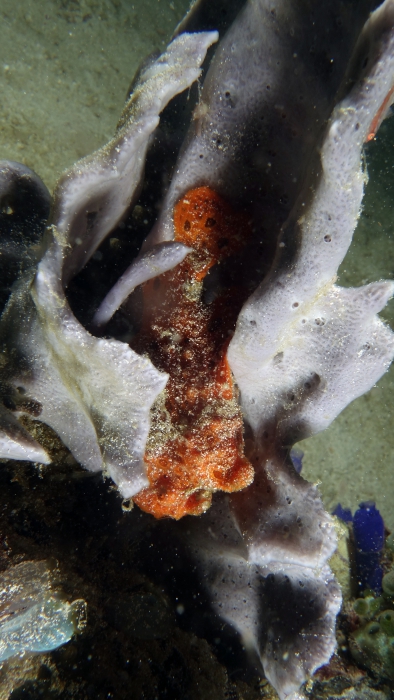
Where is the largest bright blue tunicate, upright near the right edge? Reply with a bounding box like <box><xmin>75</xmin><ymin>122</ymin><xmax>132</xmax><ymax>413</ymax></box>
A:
<box><xmin>353</xmin><ymin>501</ymin><xmax>384</xmax><ymax>594</ymax></box>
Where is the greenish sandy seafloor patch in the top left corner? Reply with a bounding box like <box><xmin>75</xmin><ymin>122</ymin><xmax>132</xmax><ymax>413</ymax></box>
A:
<box><xmin>0</xmin><ymin>0</ymin><xmax>189</xmax><ymax>189</ymax></box>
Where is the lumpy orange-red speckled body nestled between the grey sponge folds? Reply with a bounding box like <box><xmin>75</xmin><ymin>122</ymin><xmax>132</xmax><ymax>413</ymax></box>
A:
<box><xmin>133</xmin><ymin>187</ymin><xmax>253</xmax><ymax>519</ymax></box>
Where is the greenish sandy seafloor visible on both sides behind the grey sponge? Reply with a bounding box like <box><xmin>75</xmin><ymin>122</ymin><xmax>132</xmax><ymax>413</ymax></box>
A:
<box><xmin>0</xmin><ymin>0</ymin><xmax>394</xmax><ymax>696</ymax></box>
